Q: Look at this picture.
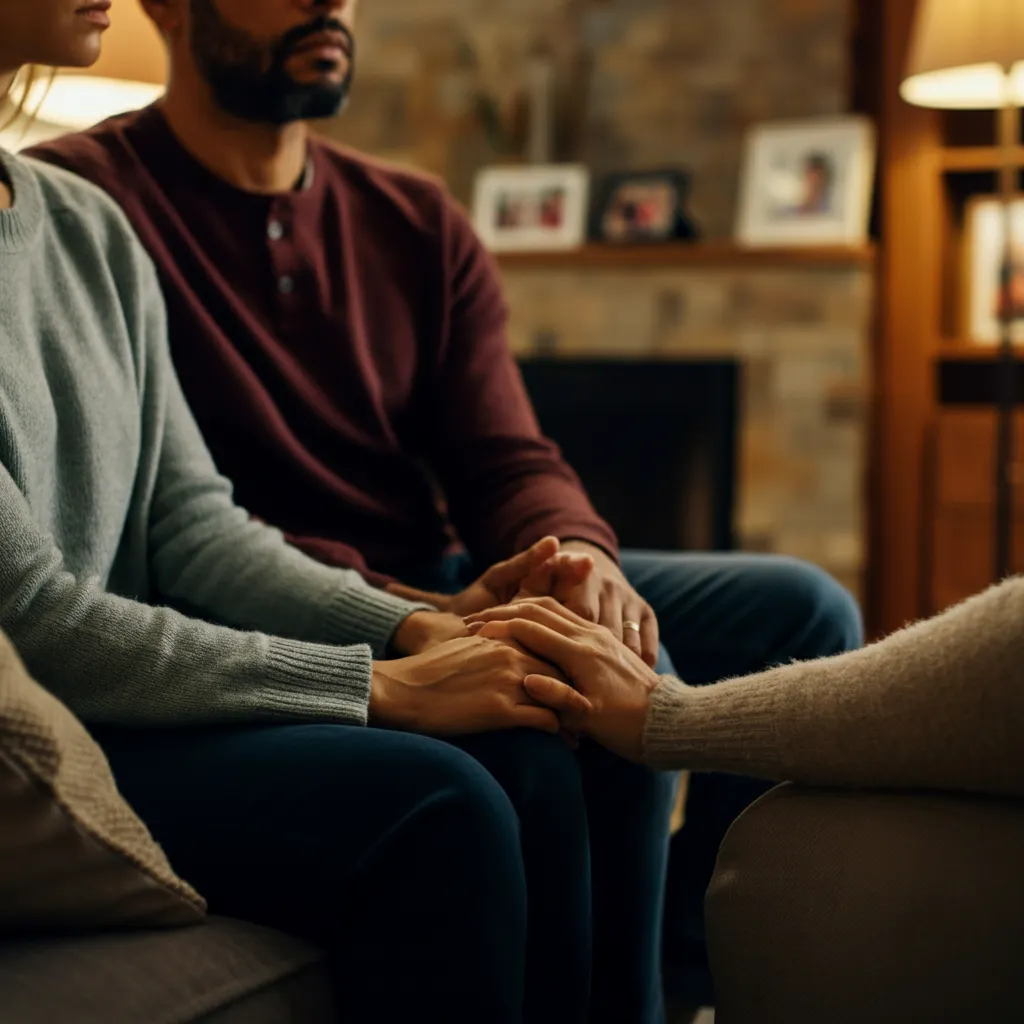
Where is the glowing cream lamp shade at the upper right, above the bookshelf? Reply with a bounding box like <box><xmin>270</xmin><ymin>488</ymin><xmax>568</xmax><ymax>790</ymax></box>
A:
<box><xmin>900</xmin><ymin>0</ymin><xmax>1024</xmax><ymax>110</ymax></box>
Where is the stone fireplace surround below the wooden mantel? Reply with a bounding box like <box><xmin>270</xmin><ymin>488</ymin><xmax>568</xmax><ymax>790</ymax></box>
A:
<box><xmin>505</xmin><ymin>264</ymin><xmax>873</xmax><ymax>595</ymax></box>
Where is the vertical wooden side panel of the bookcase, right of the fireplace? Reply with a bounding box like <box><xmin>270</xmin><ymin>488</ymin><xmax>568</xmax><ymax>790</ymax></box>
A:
<box><xmin>868</xmin><ymin>2</ymin><xmax>943</xmax><ymax>635</ymax></box>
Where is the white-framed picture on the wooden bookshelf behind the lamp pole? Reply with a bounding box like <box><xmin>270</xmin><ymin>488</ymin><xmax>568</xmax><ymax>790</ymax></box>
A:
<box><xmin>963</xmin><ymin>196</ymin><xmax>1024</xmax><ymax>345</ymax></box>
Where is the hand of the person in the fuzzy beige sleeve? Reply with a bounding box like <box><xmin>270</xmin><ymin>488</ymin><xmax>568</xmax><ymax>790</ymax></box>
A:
<box><xmin>466</xmin><ymin>597</ymin><xmax>658</xmax><ymax>761</ymax></box>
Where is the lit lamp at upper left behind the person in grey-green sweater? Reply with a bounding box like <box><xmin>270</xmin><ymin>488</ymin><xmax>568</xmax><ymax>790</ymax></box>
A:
<box><xmin>8</xmin><ymin>0</ymin><xmax>167</xmax><ymax>147</ymax></box>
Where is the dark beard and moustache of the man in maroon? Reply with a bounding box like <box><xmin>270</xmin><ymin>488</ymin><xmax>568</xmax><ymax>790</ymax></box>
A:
<box><xmin>191</xmin><ymin>0</ymin><xmax>355</xmax><ymax>125</ymax></box>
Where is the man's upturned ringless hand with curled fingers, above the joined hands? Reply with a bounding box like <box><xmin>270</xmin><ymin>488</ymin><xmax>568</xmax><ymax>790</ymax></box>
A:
<box><xmin>387</xmin><ymin>537</ymin><xmax>593</xmax><ymax>615</ymax></box>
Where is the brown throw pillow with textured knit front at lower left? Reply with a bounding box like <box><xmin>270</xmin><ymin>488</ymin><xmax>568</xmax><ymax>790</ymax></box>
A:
<box><xmin>0</xmin><ymin>633</ymin><xmax>206</xmax><ymax>932</ymax></box>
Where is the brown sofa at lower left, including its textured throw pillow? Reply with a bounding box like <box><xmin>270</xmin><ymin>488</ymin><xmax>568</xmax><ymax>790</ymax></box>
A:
<box><xmin>0</xmin><ymin>633</ymin><xmax>340</xmax><ymax>1024</ymax></box>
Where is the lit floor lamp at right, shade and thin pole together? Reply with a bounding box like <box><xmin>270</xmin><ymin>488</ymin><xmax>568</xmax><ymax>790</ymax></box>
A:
<box><xmin>900</xmin><ymin>0</ymin><xmax>1024</xmax><ymax>581</ymax></box>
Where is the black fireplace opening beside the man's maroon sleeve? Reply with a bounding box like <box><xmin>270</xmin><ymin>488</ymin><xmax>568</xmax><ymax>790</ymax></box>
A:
<box><xmin>521</xmin><ymin>358</ymin><xmax>739</xmax><ymax>551</ymax></box>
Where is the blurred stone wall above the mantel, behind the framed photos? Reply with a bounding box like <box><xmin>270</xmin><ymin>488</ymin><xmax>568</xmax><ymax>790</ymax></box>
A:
<box><xmin>326</xmin><ymin>0</ymin><xmax>850</xmax><ymax>238</ymax></box>
